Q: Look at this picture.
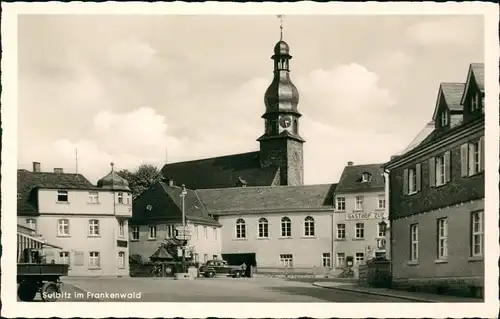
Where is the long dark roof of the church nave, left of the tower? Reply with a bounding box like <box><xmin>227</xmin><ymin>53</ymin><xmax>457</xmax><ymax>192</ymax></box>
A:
<box><xmin>161</xmin><ymin>152</ymin><xmax>278</xmax><ymax>189</ymax></box>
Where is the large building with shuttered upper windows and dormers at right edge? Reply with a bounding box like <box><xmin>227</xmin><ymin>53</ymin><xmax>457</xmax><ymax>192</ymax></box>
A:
<box><xmin>385</xmin><ymin>64</ymin><xmax>485</xmax><ymax>298</ymax></box>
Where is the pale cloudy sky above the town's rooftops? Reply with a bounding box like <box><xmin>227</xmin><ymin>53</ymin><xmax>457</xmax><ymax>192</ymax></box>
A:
<box><xmin>18</xmin><ymin>15</ymin><xmax>484</xmax><ymax>184</ymax></box>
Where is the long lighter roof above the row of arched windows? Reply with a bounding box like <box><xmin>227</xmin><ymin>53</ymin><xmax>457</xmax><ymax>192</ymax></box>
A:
<box><xmin>196</xmin><ymin>184</ymin><xmax>336</xmax><ymax>215</ymax></box>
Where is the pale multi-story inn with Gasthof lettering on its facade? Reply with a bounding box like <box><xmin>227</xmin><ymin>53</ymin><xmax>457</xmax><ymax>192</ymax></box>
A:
<box><xmin>334</xmin><ymin>162</ymin><xmax>387</xmax><ymax>276</ymax></box>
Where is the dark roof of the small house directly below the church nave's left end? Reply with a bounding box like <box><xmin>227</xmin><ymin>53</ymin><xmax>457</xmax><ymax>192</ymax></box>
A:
<box><xmin>130</xmin><ymin>182</ymin><xmax>220</xmax><ymax>226</ymax></box>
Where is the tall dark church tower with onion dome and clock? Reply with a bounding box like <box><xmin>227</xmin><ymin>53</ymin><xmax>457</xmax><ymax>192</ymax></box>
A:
<box><xmin>258</xmin><ymin>17</ymin><xmax>305</xmax><ymax>186</ymax></box>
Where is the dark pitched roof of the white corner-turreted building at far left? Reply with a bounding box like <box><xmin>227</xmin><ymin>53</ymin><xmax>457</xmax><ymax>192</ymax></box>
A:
<box><xmin>17</xmin><ymin>169</ymin><xmax>96</xmax><ymax>213</ymax></box>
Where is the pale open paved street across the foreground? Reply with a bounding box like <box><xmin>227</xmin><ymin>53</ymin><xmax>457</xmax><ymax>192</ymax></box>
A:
<box><xmin>48</xmin><ymin>278</ymin><xmax>414</xmax><ymax>302</ymax></box>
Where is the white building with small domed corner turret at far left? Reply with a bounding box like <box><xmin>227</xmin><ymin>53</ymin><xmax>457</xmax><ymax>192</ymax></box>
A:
<box><xmin>17</xmin><ymin>162</ymin><xmax>132</xmax><ymax>276</ymax></box>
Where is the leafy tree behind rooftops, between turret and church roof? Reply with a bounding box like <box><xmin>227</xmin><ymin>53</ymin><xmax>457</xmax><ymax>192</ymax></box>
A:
<box><xmin>117</xmin><ymin>164</ymin><xmax>162</xmax><ymax>199</ymax></box>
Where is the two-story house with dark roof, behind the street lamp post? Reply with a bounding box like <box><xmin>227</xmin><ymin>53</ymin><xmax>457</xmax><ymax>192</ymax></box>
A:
<box><xmin>129</xmin><ymin>180</ymin><xmax>221</xmax><ymax>262</ymax></box>
